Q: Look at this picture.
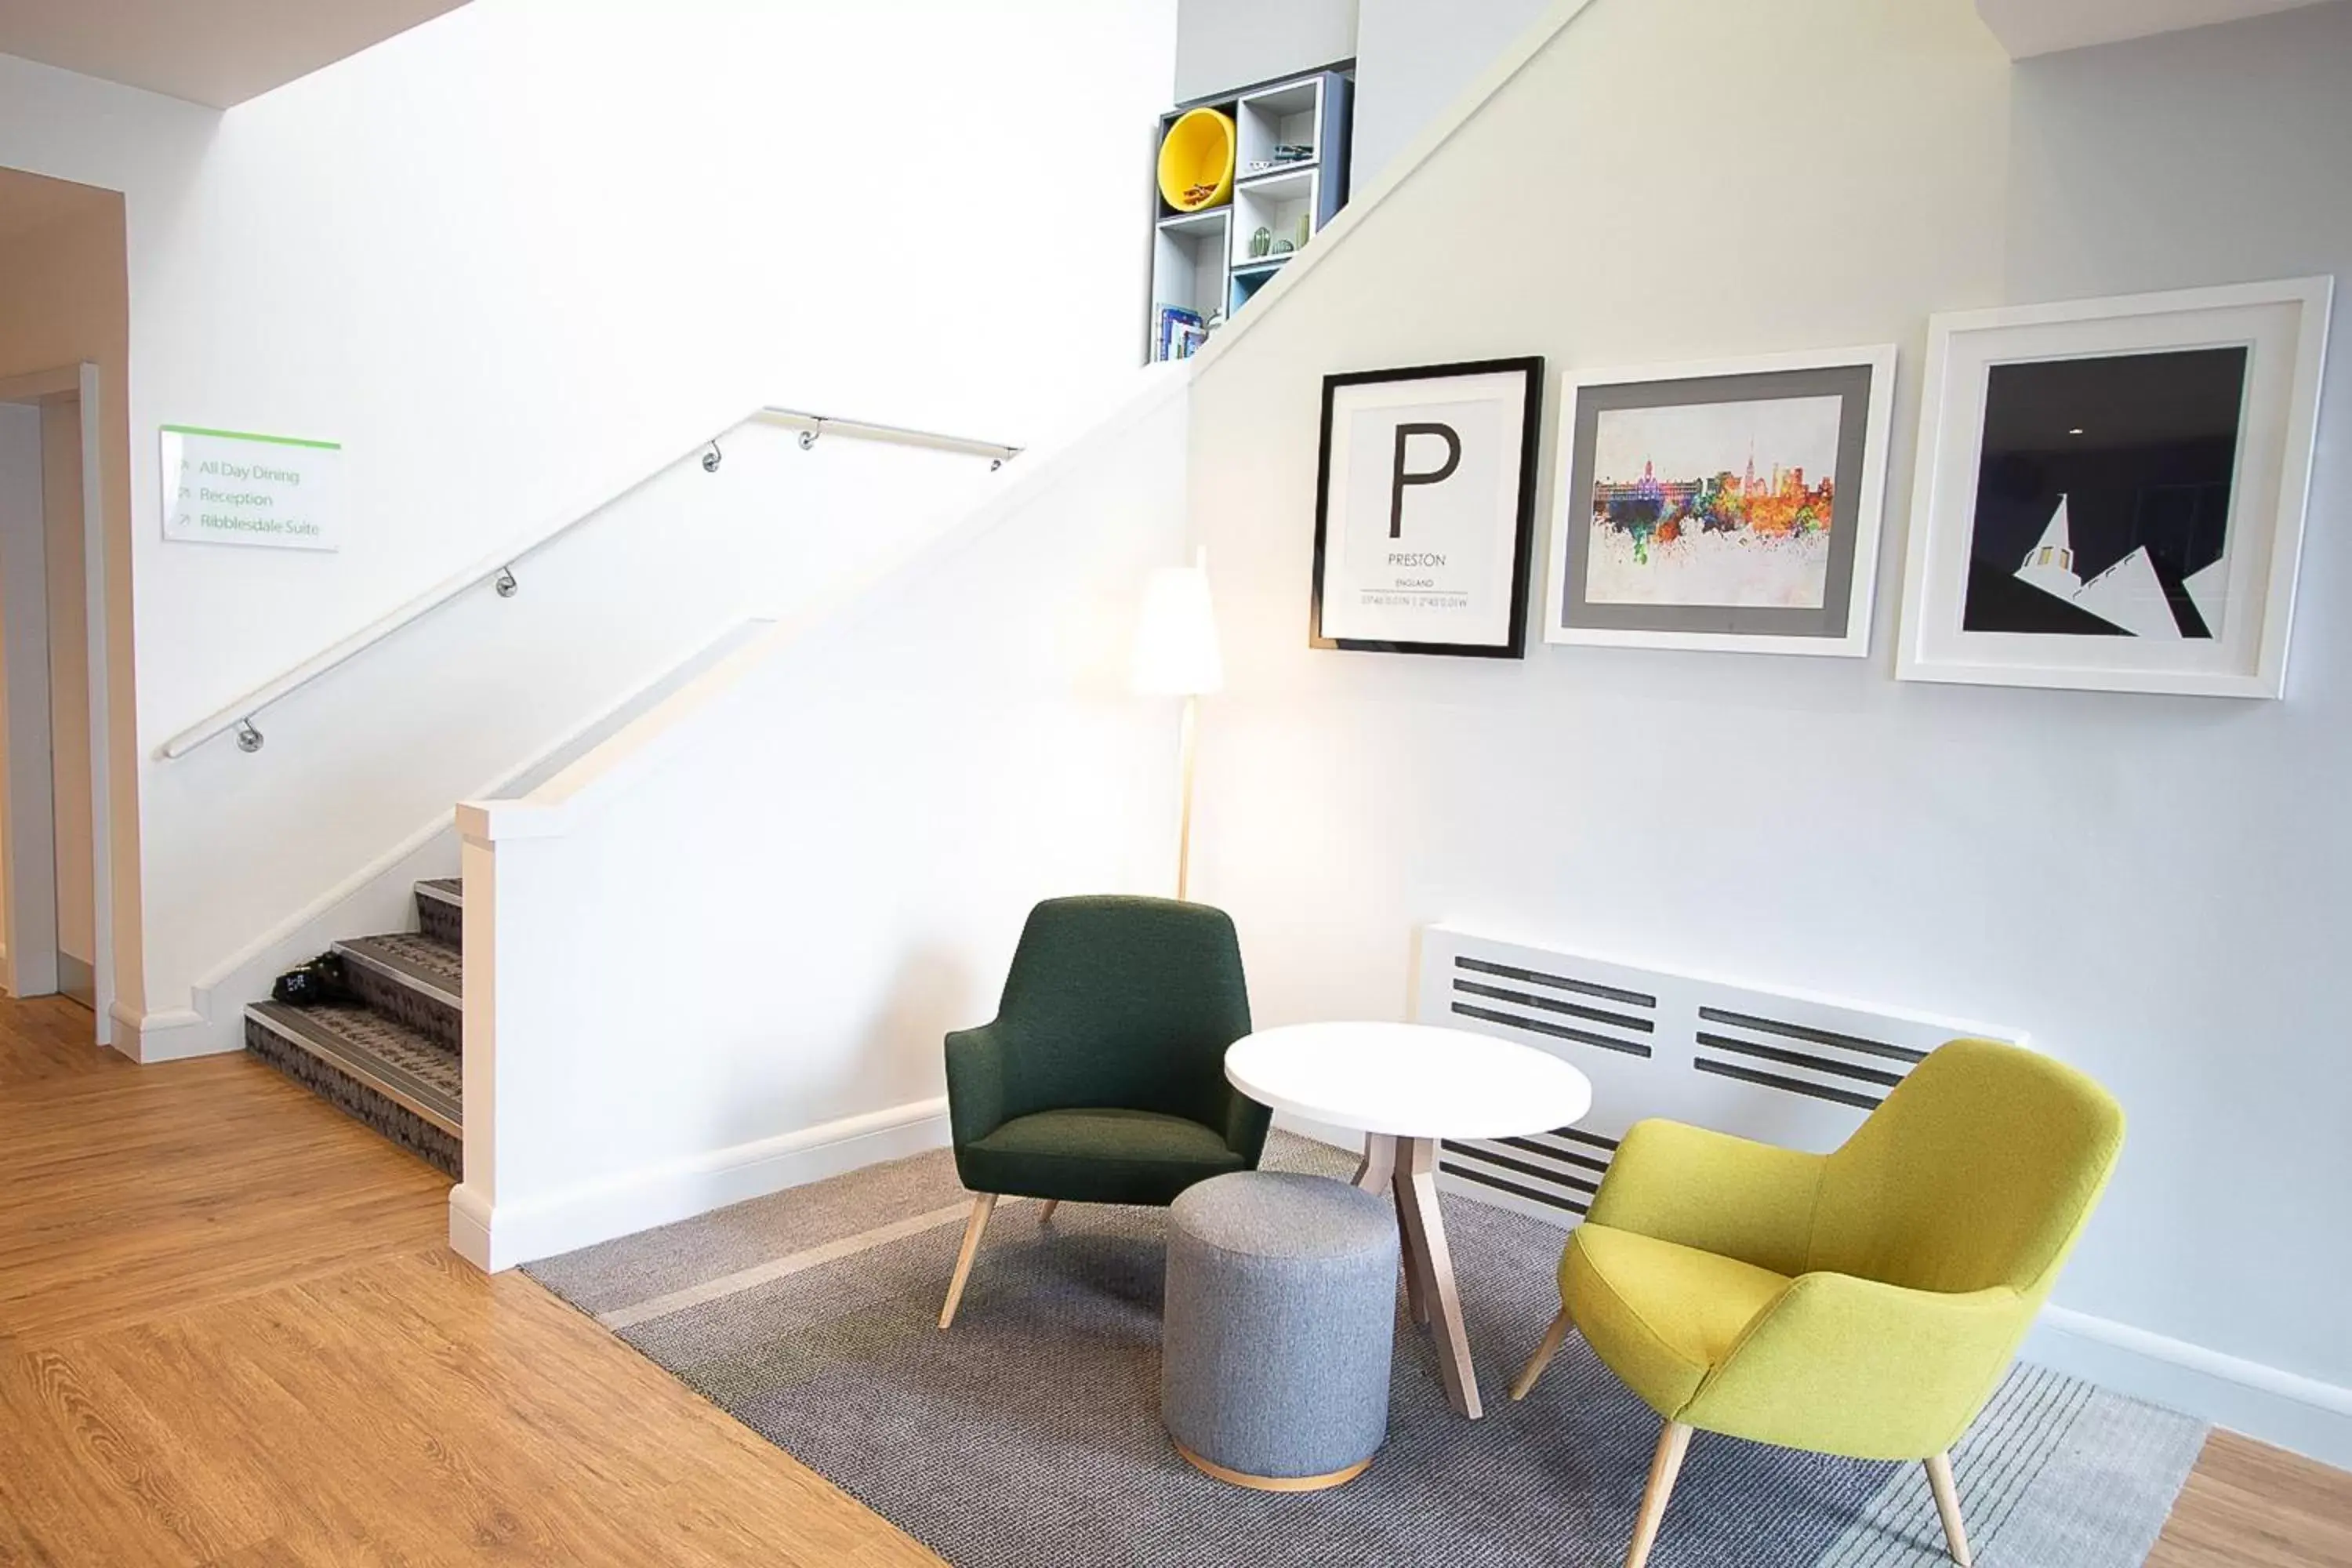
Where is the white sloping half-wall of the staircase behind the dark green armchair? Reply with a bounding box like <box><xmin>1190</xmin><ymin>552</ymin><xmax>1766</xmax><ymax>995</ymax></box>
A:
<box><xmin>452</xmin><ymin>372</ymin><xmax>1185</xmax><ymax>1267</ymax></box>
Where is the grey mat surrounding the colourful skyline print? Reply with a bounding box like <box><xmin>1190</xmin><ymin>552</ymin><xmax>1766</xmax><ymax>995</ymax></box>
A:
<box><xmin>1559</xmin><ymin>365</ymin><xmax>1872</xmax><ymax>640</ymax></box>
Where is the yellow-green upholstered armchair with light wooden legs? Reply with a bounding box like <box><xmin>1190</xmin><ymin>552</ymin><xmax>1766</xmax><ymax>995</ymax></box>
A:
<box><xmin>1510</xmin><ymin>1039</ymin><xmax>2124</xmax><ymax>1568</ymax></box>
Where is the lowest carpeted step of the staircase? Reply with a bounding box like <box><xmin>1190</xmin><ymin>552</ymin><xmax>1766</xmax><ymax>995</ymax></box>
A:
<box><xmin>245</xmin><ymin>1001</ymin><xmax>466</xmax><ymax>1178</ymax></box>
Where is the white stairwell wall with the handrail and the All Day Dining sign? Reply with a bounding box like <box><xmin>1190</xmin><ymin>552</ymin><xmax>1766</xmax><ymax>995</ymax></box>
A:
<box><xmin>0</xmin><ymin>0</ymin><xmax>1174</xmax><ymax>1053</ymax></box>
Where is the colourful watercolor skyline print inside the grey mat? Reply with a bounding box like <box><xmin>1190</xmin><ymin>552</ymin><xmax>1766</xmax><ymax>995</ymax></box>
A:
<box><xmin>1585</xmin><ymin>397</ymin><xmax>1844</xmax><ymax>609</ymax></box>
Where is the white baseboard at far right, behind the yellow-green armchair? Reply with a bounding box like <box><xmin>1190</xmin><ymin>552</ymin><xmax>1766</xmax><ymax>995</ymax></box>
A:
<box><xmin>2020</xmin><ymin>1307</ymin><xmax>2352</xmax><ymax>1469</ymax></box>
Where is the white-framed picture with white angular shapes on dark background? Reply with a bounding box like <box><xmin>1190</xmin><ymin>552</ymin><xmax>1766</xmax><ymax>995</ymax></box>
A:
<box><xmin>1896</xmin><ymin>278</ymin><xmax>2333</xmax><ymax>699</ymax></box>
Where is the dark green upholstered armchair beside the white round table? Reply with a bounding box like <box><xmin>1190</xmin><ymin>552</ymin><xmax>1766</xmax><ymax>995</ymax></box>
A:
<box><xmin>938</xmin><ymin>898</ymin><xmax>1272</xmax><ymax>1328</ymax></box>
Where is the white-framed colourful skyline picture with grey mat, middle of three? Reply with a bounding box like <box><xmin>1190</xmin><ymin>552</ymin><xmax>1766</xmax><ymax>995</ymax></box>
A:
<box><xmin>1543</xmin><ymin>346</ymin><xmax>1896</xmax><ymax>659</ymax></box>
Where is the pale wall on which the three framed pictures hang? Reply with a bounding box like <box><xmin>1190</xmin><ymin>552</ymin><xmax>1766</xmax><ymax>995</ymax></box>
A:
<box><xmin>1190</xmin><ymin>0</ymin><xmax>2352</xmax><ymax>1460</ymax></box>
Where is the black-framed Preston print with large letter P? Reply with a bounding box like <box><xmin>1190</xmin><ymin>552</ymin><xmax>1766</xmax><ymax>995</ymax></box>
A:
<box><xmin>1310</xmin><ymin>360</ymin><xmax>1543</xmax><ymax>659</ymax></box>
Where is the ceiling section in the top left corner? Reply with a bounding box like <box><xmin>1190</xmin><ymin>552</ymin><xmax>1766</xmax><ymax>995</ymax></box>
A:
<box><xmin>0</xmin><ymin>0</ymin><xmax>463</xmax><ymax>108</ymax></box>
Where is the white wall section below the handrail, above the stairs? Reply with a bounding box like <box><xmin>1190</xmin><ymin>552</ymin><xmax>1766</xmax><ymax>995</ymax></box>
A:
<box><xmin>139</xmin><ymin>409</ymin><xmax>1014</xmax><ymax>1060</ymax></box>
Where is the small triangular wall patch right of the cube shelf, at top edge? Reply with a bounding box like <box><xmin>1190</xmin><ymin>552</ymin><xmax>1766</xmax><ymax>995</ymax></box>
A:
<box><xmin>1348</xmin><ymin>0</ymin><xmax>1552</xmax><ymax>191</ymax></box>
